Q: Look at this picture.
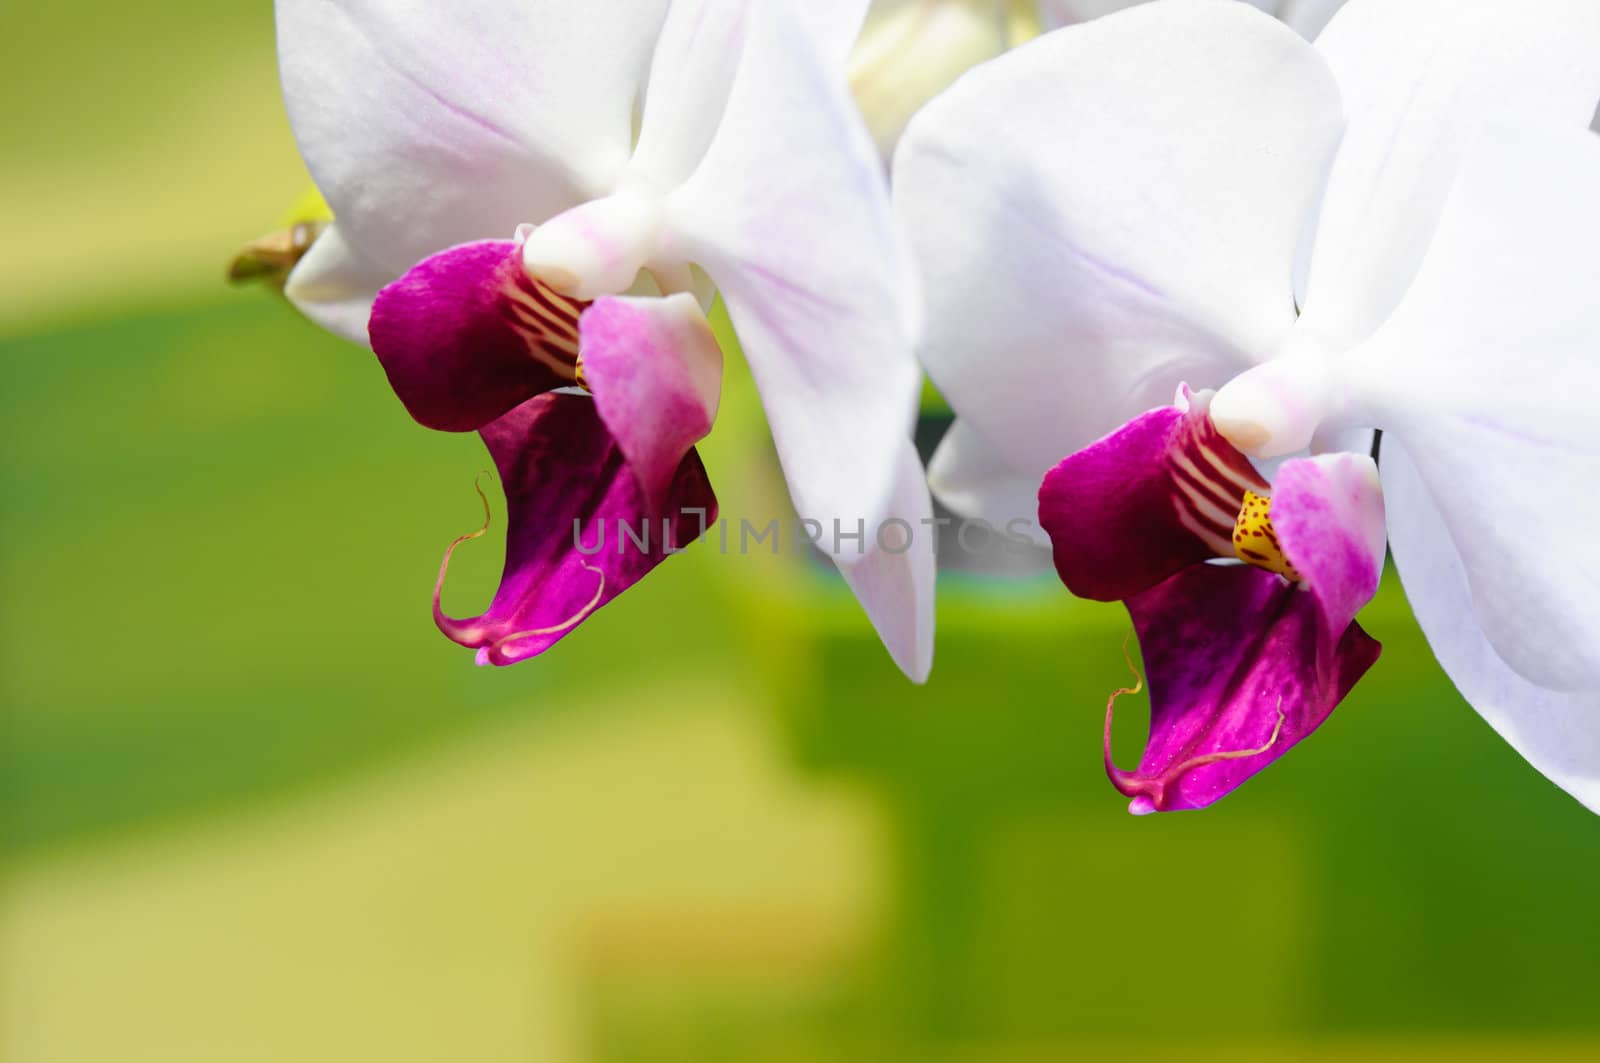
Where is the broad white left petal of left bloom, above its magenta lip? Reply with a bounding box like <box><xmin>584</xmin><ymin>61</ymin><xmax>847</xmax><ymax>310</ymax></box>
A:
<box><xmin>277</xmin><ymin>0</ymin><xmax>666</xmax><ymax>275</ymax></box>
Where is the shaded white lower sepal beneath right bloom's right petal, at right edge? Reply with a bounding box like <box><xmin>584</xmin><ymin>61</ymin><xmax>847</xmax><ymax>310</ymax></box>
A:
<box><xmin>1382</xmin><ymin>440</ymin><xmax>1600</xmax><ymax>812</ymax></box>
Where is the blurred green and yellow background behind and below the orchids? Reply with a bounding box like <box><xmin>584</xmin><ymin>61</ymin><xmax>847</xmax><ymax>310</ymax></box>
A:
<box><xmin>0</xmin><ymin>0</ymin><xmax>1600</xmax><ymax>1063</ymax></box>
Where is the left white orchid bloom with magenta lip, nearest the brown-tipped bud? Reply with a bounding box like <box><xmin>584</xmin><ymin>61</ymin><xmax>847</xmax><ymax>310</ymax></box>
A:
<box><xmin>277</xmin><ymin>0</ymin><xmax>933</xmax><ymax>680</ymax></box>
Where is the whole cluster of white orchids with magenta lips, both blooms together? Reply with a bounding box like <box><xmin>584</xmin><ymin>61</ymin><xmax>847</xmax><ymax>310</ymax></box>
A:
<box><xmin>268</xmin><ymin>0</ymin><xmax>1600</xmax><ymax>813</ymax></box>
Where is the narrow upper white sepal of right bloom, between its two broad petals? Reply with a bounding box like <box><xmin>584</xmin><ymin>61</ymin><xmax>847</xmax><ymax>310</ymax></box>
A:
<box><xmin>1304</xmin><ymin>0</ymin><xmax>1600</xmax><ymax>344</ymax></box>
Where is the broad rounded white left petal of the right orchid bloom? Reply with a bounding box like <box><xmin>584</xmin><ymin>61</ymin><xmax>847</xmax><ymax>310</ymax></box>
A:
<box><xmin>894</xmin><ymin>0</ymin><xmax>1341</xmax><ymax>479</ymax></box>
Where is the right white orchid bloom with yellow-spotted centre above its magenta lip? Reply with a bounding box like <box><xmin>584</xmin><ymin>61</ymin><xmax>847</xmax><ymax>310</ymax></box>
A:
<box><xmin>894</xmin><ymin>0</ymin><xmax>1600</xmax><ymax>812</ymax></box>
